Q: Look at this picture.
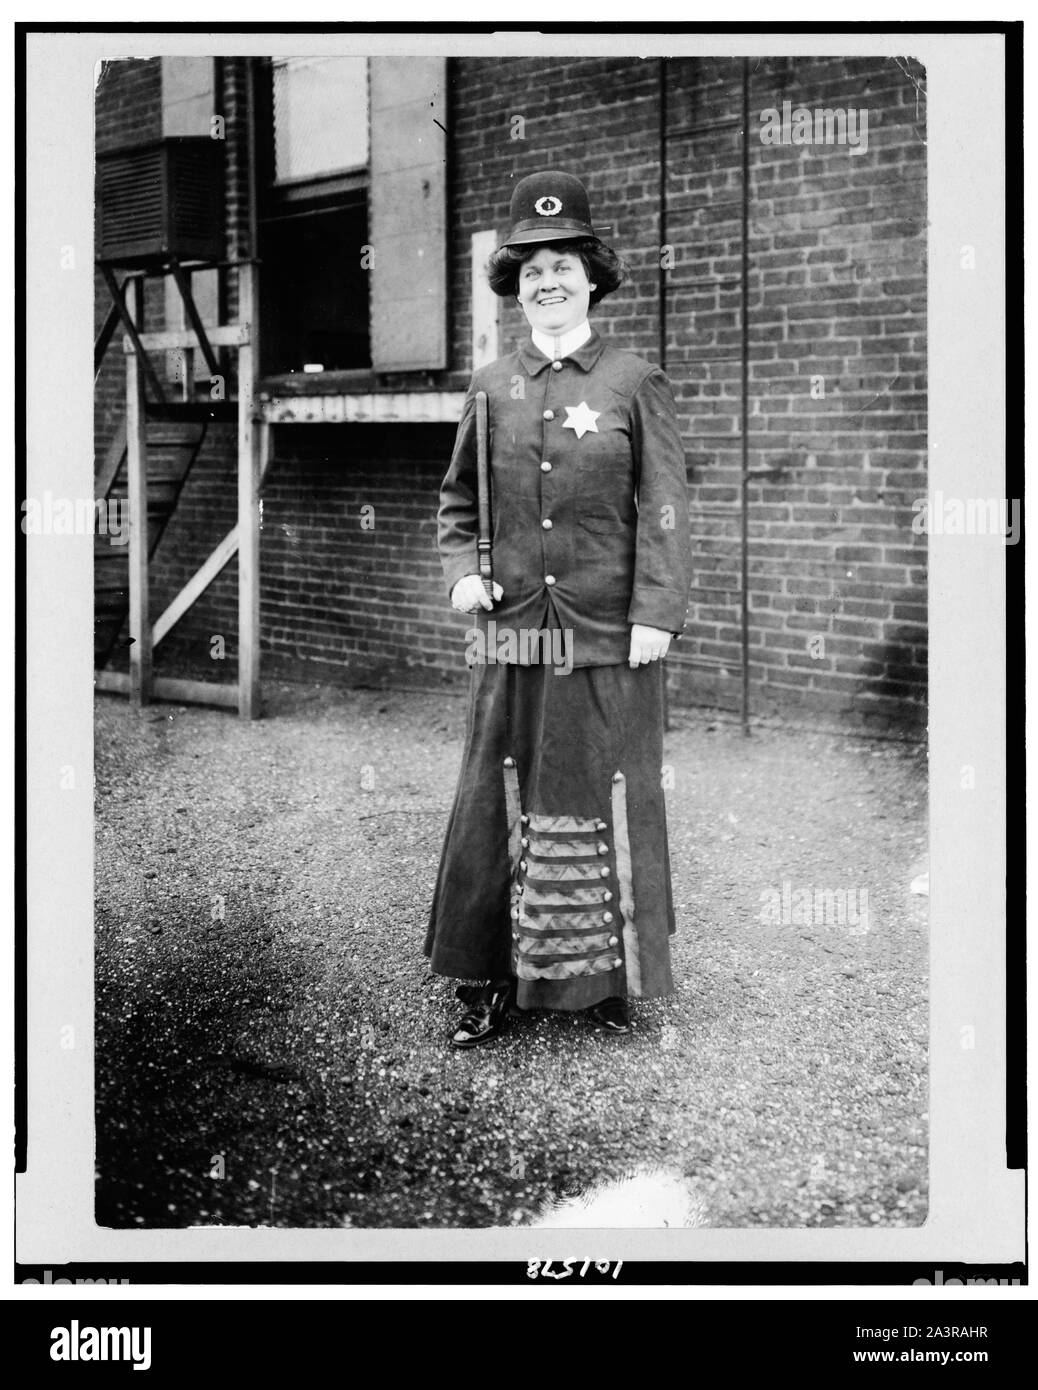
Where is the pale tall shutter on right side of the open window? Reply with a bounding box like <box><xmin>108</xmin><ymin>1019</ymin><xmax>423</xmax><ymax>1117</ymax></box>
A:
<box><xmin>370</xmin><ymin>58</ymin><xmax>447</xmax><ymax>371</ymax></box>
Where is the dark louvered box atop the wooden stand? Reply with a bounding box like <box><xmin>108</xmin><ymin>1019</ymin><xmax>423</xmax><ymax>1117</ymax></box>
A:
<box><xmin>97</xmin><ymin>135</ymin><xmax>224</xmax><ymax>267</ymax></box>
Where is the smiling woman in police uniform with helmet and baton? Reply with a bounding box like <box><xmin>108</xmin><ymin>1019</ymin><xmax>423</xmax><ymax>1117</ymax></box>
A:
<box><xmin>425</xmin><ymin>171</ymin><xmax>691</xmax><ymax>1047</ymax></box>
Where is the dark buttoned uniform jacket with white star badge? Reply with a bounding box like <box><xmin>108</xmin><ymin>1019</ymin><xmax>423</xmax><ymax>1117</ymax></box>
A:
<box><xmin>438</xmin><ymin>331</ymin><xmax>692</xmax><ymax>666</ymax></box>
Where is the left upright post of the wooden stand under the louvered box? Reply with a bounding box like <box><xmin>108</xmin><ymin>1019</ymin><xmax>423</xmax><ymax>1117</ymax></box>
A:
<box><xmin>126</xmin><ymin>279</ymin><xmax>151</xmax><ymax>706</ymax></box>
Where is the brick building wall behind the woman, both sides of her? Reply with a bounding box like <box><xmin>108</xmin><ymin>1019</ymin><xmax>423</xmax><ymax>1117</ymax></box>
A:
<box><xmin>99</xmin><ymin>58</ymin><xmax>925</xmax><ymax>726</ymax></box>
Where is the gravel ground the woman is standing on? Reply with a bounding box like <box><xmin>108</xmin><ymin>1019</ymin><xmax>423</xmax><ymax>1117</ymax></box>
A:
<box><xmin>96</xmin><ymin>685</ymin><xmax>927</xmax><ymax>1227</ymax></box>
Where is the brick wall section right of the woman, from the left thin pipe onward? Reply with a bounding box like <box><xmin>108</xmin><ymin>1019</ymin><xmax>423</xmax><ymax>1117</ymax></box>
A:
<box><xmin>668</xmin><ymin>58</ymin><xmax>925</xmax><ymax>724</ymax></box>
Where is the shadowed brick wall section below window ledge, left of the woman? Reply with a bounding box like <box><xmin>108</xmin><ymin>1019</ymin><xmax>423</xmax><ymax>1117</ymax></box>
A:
<box><xmin>143</xmin><ymin>425</ymin><xmax>468</xmax><ymax>685</ymax></box>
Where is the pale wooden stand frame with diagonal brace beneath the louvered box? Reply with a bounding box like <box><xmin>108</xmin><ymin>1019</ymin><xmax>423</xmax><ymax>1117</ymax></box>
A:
<box><xmin>94</xmin><ymin>260</ymin><xmax>271</xmax><ymax>719</ymax></box>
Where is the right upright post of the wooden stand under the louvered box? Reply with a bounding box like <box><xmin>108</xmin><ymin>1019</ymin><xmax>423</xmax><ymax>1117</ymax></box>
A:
<box><xmin>238</xmin><ymin>260</ymin><xmax>268</xmax><ymax>719</ymax></box>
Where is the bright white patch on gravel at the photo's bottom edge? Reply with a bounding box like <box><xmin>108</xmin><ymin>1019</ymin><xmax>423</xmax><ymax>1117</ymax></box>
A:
<box><xmin>518</xmin><ymin>1166</ymin><xmax>707</xmax><ymax>1230</ymax></box>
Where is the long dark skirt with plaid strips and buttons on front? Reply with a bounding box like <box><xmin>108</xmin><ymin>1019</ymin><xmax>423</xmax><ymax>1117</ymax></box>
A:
<box><xmin>425</xmin><ymin>663</ymin><xmax>674</xmax><ymax>1009</ymax></box>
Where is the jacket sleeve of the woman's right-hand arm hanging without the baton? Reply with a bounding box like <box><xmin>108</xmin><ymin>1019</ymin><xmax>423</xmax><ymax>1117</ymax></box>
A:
<box><xmin>627</xmin><ymin>367</ymin><xmax>692</xmax><ymax>634</ymax></box>
